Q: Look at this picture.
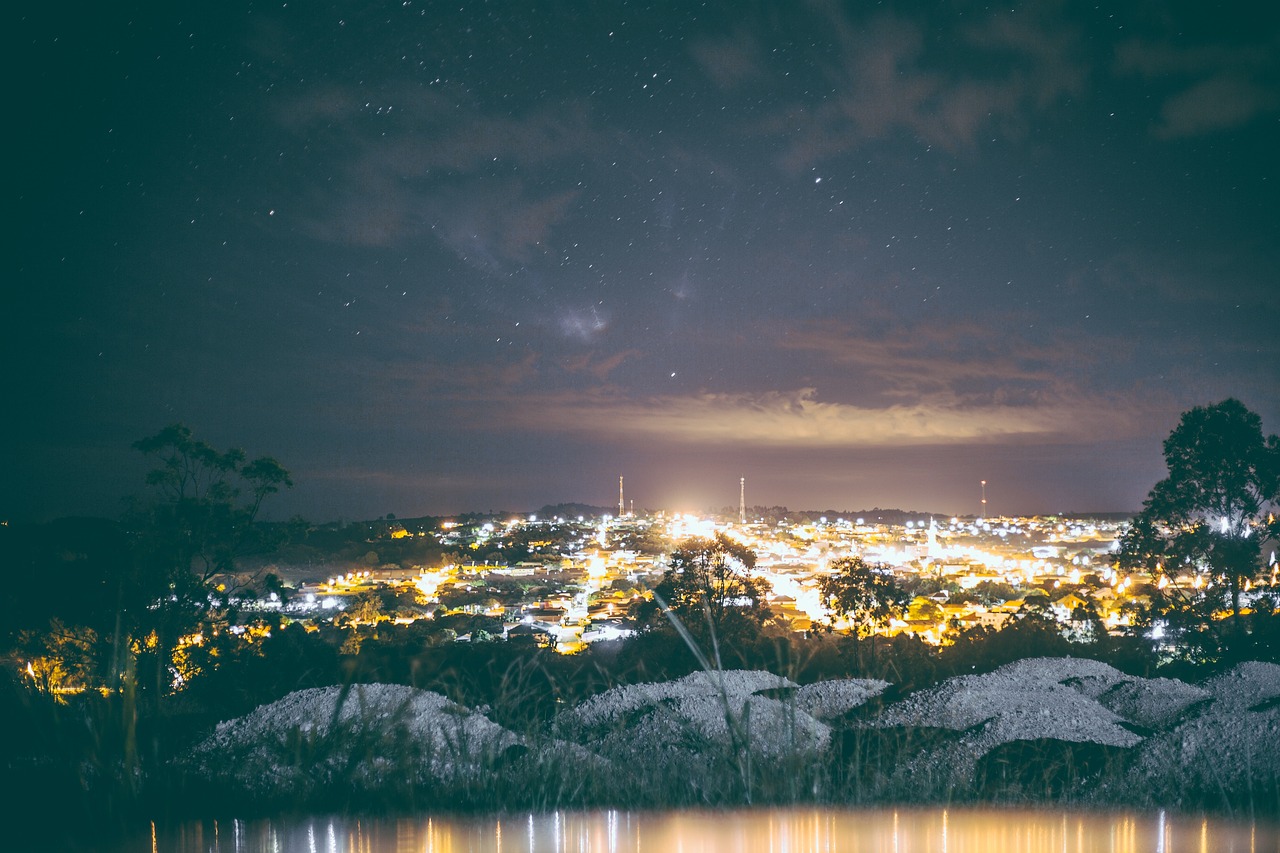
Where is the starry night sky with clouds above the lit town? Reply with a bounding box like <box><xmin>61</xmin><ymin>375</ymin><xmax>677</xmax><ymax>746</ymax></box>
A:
<box><xmin>10</xmin><ymin>0</ymin><xmax>1280</xmax><ymax>521</ymax></box>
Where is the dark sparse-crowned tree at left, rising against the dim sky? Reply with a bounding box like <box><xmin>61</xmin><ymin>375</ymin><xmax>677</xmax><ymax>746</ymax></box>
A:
<box><xmin>120</xmin><ymin>424</ymin><xmax>293</xmax><ymax>692</ymax></box>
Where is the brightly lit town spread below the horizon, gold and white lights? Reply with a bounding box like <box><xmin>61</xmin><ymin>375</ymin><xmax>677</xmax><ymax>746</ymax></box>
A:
<box><xmin>193</xmin><ymin>510</ymin><xmax>1198</xmax><ymax>653</ymax></box>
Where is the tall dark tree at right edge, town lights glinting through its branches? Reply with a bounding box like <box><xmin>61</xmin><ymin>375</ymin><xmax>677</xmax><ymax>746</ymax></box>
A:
<box><xmin>1117</xmin><ymin>400</ymin><xmax>1280</xmax><ymax>648</ymax></box>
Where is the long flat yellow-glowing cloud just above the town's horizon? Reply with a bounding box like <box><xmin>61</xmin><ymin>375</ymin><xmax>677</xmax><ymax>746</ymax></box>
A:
<box><xmin>521</xmin><ymin>388</ymin><xmax>1129</xmax><ymax>448</ymax></box>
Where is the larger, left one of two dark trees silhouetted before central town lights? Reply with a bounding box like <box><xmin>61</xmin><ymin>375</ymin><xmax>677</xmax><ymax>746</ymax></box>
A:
<box><xmin>654</xmin><ymin>533</ymin><xmax>769</xmax><ymax>643</ymax></box>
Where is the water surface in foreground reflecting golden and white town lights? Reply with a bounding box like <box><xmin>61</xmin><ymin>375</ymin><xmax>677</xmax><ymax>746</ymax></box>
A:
<box><xmin>119</xmin><ymin>808</ymin><xmax>1280</xmax><ymax>853</ymax></box>
